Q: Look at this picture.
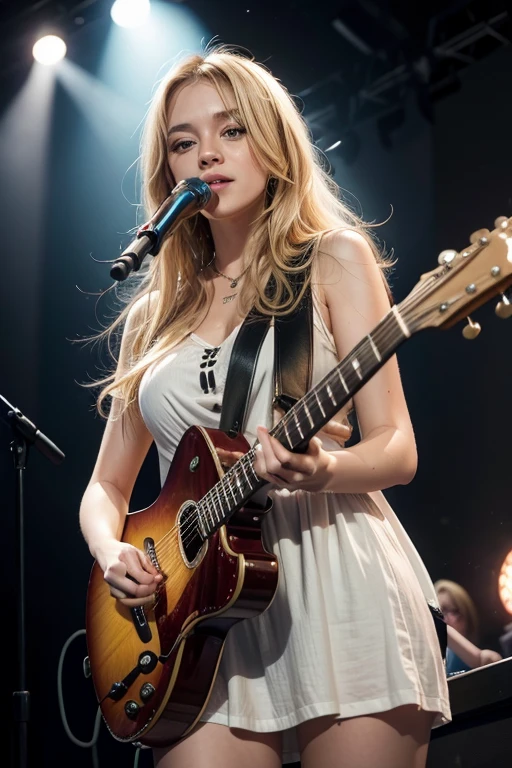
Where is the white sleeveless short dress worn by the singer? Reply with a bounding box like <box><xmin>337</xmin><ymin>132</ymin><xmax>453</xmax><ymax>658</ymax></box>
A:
<box><xmin>139</xmin><ymin>308</ymin><xmax>451</xmax><ymax>763</ymax></box>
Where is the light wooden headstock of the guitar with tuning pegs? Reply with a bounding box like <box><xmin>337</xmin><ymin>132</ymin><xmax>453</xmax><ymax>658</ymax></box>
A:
<box><xmin>400</xmin><ymin>216</ymin><xmax>512</xmax><ymax>338</ymax></box>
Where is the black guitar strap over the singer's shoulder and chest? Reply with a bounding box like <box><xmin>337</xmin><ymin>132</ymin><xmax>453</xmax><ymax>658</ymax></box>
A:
<box><xmin>220</xmin><ymin>251</ymin><xmax>313</xmax><ymax>437</ymax></box>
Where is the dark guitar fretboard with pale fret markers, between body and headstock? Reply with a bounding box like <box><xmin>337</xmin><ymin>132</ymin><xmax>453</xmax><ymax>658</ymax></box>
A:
<box><xmin>198</xmin><ymin>305</ymin><xmax>412</xmax><ymax>538</ymax></box>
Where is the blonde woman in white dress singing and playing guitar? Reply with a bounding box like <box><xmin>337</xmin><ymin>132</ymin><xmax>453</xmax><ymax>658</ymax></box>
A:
<box><xmin>80</xmin><ymin>49</ymin><xmax>450</xmax><ymax>768</ymax></box>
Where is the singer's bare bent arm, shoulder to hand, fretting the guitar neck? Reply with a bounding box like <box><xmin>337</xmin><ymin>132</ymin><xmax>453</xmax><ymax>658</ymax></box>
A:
<box><xmin>255</xmin><ymin>231</ymin><xmax>417</xmax><ymax>493</ymax></box>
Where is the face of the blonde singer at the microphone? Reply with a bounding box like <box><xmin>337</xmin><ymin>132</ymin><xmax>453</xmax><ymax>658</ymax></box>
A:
<box><xmin>168</xmin><ymin>82</ymin><xmax>268</xmax><ymax>224</ymax></box>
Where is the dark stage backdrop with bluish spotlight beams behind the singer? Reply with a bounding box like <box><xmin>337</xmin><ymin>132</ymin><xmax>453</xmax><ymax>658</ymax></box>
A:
<box><xmin>0</xmin><ymin>0</ymin><xmax>512</xmax><ymax>768</ymax></box>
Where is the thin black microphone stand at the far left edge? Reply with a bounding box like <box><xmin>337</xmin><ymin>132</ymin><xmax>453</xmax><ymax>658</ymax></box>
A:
<box><xmin>0</xmin><ymin>395</ymin><xmax>64</xmax><ymax>768</ymax></box>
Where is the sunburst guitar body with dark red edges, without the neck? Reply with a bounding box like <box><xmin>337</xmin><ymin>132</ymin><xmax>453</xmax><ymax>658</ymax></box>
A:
<box><xmin>86</xmin><ymin>427</ymin><xmax>278</xmax><ymax>746</ymax></box>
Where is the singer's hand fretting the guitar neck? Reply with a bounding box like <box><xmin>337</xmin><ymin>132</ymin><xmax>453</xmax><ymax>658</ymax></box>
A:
<box><xmin>254</xmin><ymin>427</ymin><xmax>336</xmax><ymax>491</ymax></box>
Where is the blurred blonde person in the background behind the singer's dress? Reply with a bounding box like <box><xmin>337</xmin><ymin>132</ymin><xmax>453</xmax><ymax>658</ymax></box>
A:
<box><xmin>434</xmin><ymin>579</ymin><xmax>502</xmax><ymax>675</ymax></box>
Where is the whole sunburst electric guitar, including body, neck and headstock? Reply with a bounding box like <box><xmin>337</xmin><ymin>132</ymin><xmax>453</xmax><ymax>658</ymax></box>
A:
<box><xmin>86</xmin><ymin>217</ymin><xmax>512</xmax><ymax>746</ymax></box>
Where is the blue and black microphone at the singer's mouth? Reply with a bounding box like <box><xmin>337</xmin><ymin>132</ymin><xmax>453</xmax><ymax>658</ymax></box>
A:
<box><xmin>110</xmin><ymin>177</ymin><xmax>217</xmax><ymax>281</ymax></box>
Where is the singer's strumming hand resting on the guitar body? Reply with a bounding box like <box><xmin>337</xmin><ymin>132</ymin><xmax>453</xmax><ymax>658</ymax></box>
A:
<box><xmin>96</xmin><ymin>539</ymin><xmax>163</xmax><ymax>608</ymax></box>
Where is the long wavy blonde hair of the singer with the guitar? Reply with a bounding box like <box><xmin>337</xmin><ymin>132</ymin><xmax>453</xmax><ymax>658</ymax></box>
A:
<box><xmin>96</xmin><ymin>46</ymin><xmax>388</xmax><ymax>415</ymax></box>
